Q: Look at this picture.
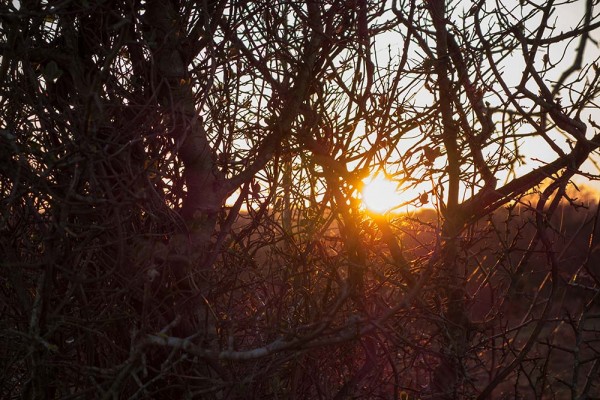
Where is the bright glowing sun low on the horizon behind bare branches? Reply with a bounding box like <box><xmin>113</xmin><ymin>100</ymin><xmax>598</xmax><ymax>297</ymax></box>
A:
<box><xmin>361</xmin><ymin>175</ymin><xmax>406</xmax><ymax>214</ymax></box>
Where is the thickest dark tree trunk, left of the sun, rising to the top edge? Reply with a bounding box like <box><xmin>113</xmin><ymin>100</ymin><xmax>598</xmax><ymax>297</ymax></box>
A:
<box><xmin>145</xmin><ymin>0</ymin><xmax>228</xmax><ymax>344</ymax></box>
